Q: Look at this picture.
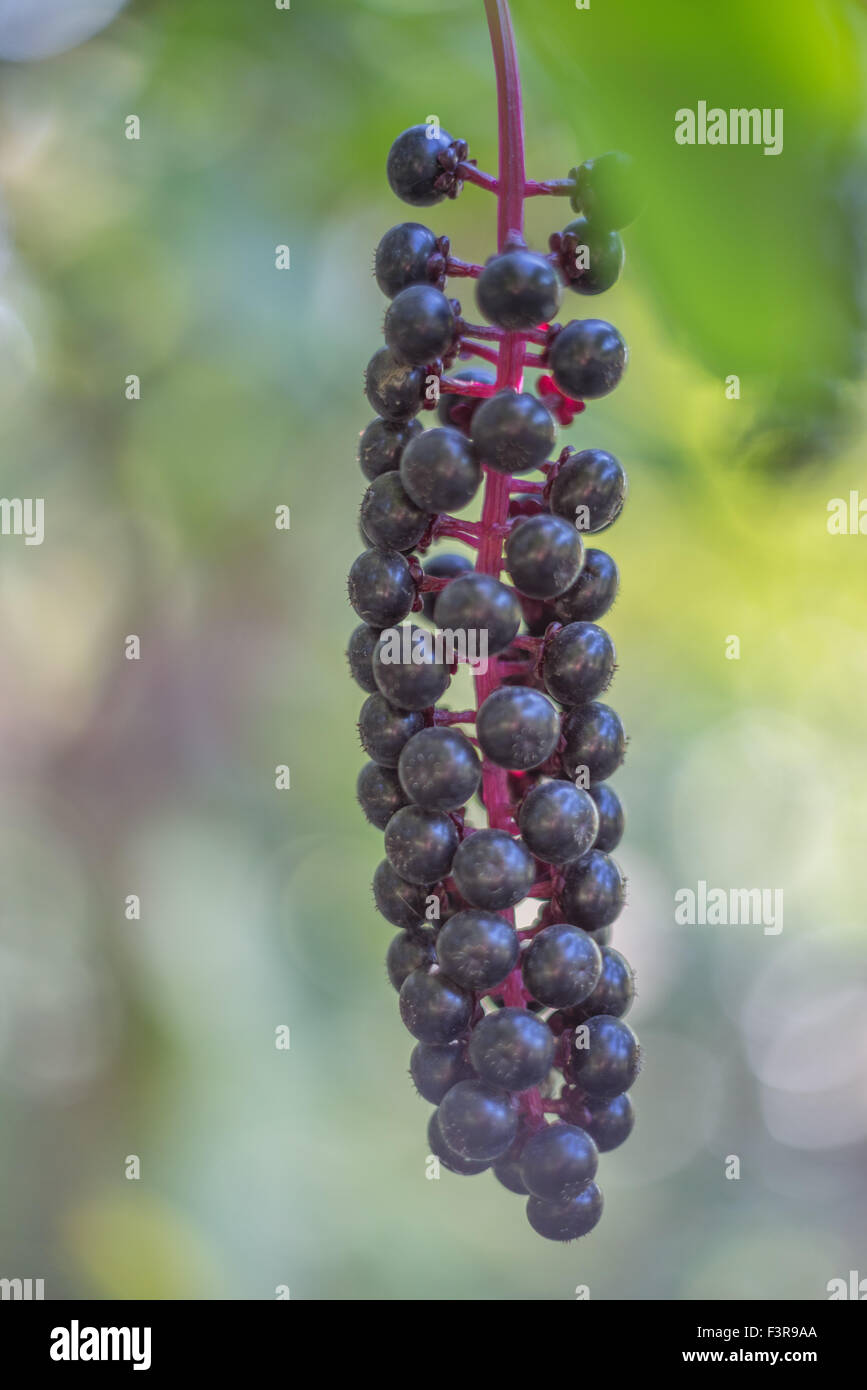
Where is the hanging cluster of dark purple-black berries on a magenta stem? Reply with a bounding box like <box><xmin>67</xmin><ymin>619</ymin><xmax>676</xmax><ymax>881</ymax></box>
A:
<box><xmin>349</xmin><ymin>0</ymin><xmax>639</xmax><ymax>1240</ymax></box>
